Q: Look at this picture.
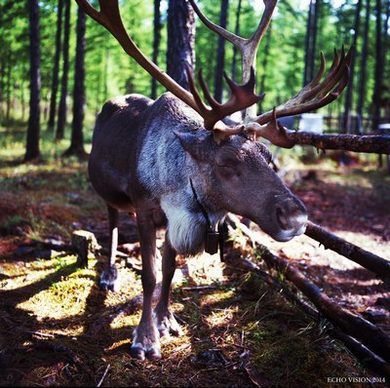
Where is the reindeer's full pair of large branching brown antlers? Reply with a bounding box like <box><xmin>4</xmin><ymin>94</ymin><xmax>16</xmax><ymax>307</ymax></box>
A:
<box><xmin>76</xmin><ymin>0</ymin><xmax>352</xmax><ymax>147</ymax></box>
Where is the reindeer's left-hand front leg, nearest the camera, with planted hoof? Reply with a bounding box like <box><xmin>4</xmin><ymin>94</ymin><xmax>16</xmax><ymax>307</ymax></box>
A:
<box><xmin>131</xmin><ymin>212</ymin><xmax>161</xmax><ymax>360</ymax></box>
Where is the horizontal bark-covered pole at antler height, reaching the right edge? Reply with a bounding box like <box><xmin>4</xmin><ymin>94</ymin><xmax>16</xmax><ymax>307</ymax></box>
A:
<box><xmin>286</xmin><ymin>131</ymin><xmax>390</xmax><ymax>154</ymax></box>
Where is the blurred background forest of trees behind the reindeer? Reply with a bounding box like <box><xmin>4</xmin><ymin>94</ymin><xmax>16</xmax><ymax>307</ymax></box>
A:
<box><xmin>0</xmin><ymin>0</ymin><xmax>390</xmax><ymax>156</ymax></box>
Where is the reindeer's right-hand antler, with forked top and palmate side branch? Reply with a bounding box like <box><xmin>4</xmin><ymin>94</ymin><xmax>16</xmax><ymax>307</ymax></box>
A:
<box><xmin>189</xmin><ymin>0</ymin><xmax>352</xmax><ymax>148</ymax></box>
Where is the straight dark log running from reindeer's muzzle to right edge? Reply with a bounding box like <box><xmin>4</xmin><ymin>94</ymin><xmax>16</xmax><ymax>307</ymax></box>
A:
<box><xmin>305</xmin><ymin>221</ymin><xmax>390</xmax><ymax>281</ymax></box>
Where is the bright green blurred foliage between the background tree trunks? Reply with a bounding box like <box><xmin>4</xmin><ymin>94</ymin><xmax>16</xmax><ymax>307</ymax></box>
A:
<box><xmin>0</xmin><ymin>0</ymin><xmax>390</xmax><ymax>136</ymax></box>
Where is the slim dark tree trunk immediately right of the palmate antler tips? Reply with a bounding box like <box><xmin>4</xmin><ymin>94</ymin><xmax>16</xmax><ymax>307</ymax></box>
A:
<box><xmin>355</xmin><ymin>0</ymin><xmax>370</xmax><ymax>133</ymax></box>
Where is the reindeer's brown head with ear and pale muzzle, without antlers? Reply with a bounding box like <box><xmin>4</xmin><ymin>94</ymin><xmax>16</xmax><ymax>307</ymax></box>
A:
<box><xmin>176</xmin><ymin>127</ymin><xmax>307</xmax><ymax>241</ymax></box>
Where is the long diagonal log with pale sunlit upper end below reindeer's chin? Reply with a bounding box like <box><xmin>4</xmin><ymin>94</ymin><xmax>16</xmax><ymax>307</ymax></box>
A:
<box><xmin>225</xmin><ymin>215</ymin><xmax>390</xmax><ymax>362</ymax></box>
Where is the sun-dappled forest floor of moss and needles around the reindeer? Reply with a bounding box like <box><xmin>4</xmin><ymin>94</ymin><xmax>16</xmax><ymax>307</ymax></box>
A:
<box><xmin>0</xmin><ymin>126</ymin><xmax>390</xmax><ymax>387</ymax></box>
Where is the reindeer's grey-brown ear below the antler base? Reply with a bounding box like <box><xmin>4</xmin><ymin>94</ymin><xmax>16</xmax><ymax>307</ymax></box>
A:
<box><xmin>174</xmin><ymin>131</ymin><xmax>215</xmax><ymax>161</ymax></box>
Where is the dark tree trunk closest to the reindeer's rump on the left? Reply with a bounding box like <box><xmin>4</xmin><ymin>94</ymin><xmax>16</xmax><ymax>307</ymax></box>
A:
<box><xmin>64</xmin><ymin>7</ymin><xmax>86</xmax><ymax>158</ymax></box>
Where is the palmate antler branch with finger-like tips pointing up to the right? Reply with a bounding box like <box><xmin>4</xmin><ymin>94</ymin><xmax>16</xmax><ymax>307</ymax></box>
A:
<box><xmin>255</xmin><ymin>48</ymin><xmax>352</xmax><ymax>124</ymax></box>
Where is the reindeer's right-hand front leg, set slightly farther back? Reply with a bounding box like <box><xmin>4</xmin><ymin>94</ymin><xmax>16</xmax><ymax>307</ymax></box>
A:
<box><xmin>154</xmin><ymin>232</ymin><xmax>182</xmax><ymax>337</ymax></box>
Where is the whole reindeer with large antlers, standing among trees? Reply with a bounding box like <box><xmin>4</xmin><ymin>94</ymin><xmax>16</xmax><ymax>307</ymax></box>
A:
<box><xmin>77</xmin><ymin>0</ymin><xmax>350</xmax><ymax>360</ymax></box>
